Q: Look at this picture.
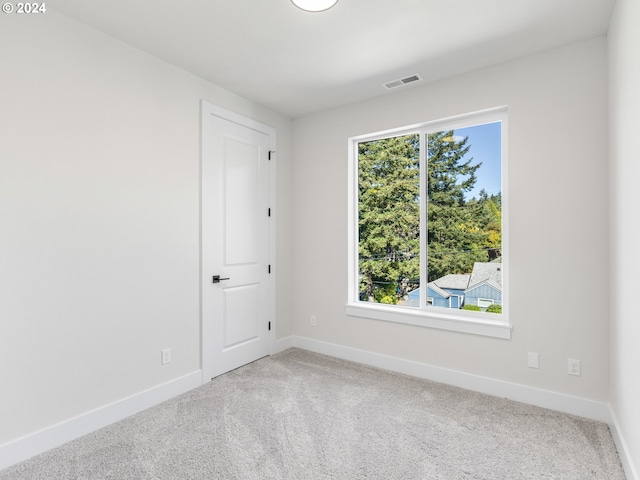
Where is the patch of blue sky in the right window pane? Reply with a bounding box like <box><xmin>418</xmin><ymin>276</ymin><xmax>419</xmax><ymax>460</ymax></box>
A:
<box><xmin>454</xmin><ymin>122</ymin><xmax>502</xmax><ymax>202</ymax></box>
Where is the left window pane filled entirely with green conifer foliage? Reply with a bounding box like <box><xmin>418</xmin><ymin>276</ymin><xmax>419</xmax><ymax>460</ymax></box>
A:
<box><xmin>358</xmin><ymin>134</ymin><xmax>420</xmax><ymax>307</ymax></box>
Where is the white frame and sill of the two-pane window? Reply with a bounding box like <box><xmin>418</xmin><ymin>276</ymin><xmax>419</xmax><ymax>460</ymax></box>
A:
<box><xmin>346</xmin><ymin>107</ymin><xmax>511</xmax><ymax>339</ymax></box>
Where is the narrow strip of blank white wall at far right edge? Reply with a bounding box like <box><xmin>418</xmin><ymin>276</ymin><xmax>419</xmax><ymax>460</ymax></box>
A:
<box><xmin>608</xmin><ymin>0</ymin><xmax>640</xmax><ymax>479</ymax></box>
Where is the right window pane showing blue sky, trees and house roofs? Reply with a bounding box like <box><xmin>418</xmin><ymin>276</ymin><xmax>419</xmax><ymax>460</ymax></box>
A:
<box><xmin>427</xmin><ymin>122</ymin><xmax>502</xmax><ymax>313</ymax></box>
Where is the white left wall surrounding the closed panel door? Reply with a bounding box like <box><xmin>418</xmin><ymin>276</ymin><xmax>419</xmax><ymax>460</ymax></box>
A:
<box><xmin>0</xmin><ymin>10</ymin><xmax>291</xmax><ymax>445</ymax></box>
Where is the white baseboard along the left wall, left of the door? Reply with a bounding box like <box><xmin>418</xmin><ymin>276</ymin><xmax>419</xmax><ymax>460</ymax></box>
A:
<box><xmin>0</xmin><ymin>370</ymin><xmax>202</xmax><ymax>470</ymax></box>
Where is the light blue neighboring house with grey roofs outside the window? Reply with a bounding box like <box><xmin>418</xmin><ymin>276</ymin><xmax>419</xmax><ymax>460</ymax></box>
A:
<box><xmin>405</xmin><ymin>261</ymin><xmax>502</xmax><ymax>308</ymax></box>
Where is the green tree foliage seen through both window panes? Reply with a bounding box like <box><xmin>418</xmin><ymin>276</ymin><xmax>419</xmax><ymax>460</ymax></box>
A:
<box><xmin>358</xmin><ymin>131</ymin><xmax>502</xmax><ymax>304</ymax></box>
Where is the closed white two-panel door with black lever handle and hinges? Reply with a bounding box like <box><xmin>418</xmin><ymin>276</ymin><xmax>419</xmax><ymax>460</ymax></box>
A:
<box><xmin>202</xmin><ymin>103</ymin><xmax>272</xmax><ymax>381</ymax></box>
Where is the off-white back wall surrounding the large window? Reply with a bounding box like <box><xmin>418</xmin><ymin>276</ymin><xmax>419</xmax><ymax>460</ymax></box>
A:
<box><xmin>292</xmin><ymin>38</ymin><xmax>609</xmax><ymax>402</ymax></box>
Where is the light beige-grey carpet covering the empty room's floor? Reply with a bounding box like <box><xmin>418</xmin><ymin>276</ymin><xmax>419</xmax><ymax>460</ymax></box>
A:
<box><xmin>0</xmin><ymin>349</ymin><xmax>625</xmax><ymax>480</ymax></box>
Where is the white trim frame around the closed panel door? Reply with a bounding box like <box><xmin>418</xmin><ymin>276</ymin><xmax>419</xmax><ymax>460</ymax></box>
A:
<box><xmin>199</xmin><ymin>100</ymin><xmax>278</xmax><ymax>384</ymax></box>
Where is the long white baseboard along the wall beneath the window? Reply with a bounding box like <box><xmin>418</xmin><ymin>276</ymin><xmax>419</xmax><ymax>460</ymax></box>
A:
<box><xmin>293</xmin><ymin>336</ymin><xmax>611</xmax><ymax>425</ymax></box>
